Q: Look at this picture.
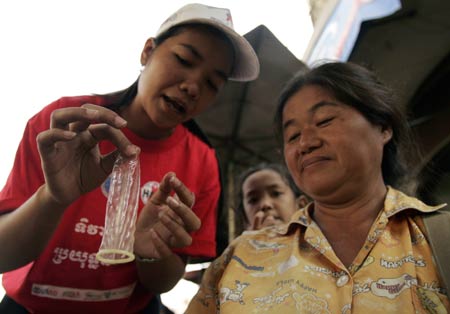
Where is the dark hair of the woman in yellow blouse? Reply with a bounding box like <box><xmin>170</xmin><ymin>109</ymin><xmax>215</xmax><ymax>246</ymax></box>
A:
<box><xmin>274</xmin><ymin>62</ymin><xmax>418</xmax><ymax>193</ymax></box>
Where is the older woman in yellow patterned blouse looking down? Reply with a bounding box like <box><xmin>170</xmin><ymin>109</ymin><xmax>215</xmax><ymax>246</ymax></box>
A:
<box><xmin>186</xmin><ymin>62</ymin><xmax>450</xmax><ymax>314</ymax></box>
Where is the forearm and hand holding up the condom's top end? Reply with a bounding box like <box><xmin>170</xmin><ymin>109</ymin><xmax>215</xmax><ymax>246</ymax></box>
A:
<box><xmin>0</xmin><ymin>105</ymin><xmax>137</xmax><ymax>273</ymax></box>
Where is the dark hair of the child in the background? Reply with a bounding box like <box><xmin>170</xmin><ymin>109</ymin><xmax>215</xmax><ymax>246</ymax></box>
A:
<box><xmin>234</xmin><ymin>162</ymin><xmax>302</xmax><ymax>235</ymax></box>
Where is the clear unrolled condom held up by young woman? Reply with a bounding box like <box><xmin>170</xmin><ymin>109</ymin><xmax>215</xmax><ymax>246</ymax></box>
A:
<box><xmin>96</xmin><ymin>155</ymin><xmax>140</xmax><ymax>264</ymax></box>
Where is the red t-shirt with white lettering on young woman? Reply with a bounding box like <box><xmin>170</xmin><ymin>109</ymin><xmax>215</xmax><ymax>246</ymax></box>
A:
<box><xmin>0</xmin><ymin>96</ymin><xmax>220</xmax><ymax>313</ymax></box>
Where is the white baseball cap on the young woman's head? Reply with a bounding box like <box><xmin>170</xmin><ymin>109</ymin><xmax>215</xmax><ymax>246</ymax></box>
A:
<box><xmin>156</xmin><ymin>3</ymin><xmax>259</xmax><ymax>82</ymax></box>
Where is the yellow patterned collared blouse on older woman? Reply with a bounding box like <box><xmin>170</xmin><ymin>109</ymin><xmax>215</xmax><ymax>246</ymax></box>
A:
<box><xmin>186</xmin><ymin>188</ymin><xmax>450</xmax><ymax>314</ymax></box>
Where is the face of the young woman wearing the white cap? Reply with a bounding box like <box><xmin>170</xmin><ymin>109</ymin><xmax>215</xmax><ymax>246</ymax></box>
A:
<box><xmin>134</xmin><ymin>27</ymin><xmax>233</xmax><ymax>134</ymax></box>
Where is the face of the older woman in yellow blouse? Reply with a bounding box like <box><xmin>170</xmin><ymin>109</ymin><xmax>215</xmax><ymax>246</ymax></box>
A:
<box><xmin>282</xmin><ymin>85</ymin><xmax>392</xmax><ymax>202</ymax></box>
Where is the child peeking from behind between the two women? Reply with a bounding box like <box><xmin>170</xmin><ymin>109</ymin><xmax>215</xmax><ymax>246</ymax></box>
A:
<box><xmin>235</xmin><ymin>162</ymin><xmax>308</xmax><ymax>235</ymax></box>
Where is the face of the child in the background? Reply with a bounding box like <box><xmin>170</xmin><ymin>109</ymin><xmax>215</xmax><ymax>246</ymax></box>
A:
<box><xmin>242</xmin><ymin>169</ymin><xmax>297</xmax><ymax>229</ymax></box>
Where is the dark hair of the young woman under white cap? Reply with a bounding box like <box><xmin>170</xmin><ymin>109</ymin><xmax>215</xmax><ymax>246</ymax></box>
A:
<box><xmin>97</xmin><ymin>23</ymin><xmax>234</xmax><ymax>112</ymax></box>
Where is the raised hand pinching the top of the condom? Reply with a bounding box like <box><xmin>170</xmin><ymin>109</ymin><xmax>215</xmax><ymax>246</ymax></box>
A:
<box><xmin>37</xmin><ymin>104</ymin><xmax>139</xmax><ymax>206</ymax></box>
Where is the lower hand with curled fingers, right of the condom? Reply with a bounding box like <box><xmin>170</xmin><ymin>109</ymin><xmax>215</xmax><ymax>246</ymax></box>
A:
<box><xmin>134</xmin><ymin>173</ymin><xmax>201</xmax><ymax>259</ymax></box>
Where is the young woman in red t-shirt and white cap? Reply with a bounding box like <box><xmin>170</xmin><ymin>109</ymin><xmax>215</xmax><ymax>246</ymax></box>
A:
<box><xmin>0</xmin><ymin>4</ymin><xmax>259</xmax><ymax>313</ymax></box>
